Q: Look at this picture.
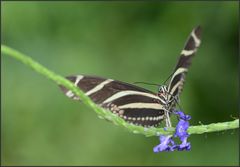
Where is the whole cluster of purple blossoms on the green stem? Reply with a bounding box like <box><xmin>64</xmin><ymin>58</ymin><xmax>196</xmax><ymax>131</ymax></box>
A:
<box><xmin>153</xmin><ymin>111</ymin><xmax>191</xmax><ymax>153</ymax></box>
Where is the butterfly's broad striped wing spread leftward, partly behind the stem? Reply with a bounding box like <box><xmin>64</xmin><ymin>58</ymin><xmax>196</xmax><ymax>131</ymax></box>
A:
<box><xmin>60</xmin><ymin>75</ymin><xmax>164</xmax><ymax>127</ymax></box>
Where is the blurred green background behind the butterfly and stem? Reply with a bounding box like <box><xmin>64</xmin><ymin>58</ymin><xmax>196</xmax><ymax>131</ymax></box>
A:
<box><xmin>1</xmin><ymin>1</ymin><xmax>239</xmax><ymax>165</ymax></box>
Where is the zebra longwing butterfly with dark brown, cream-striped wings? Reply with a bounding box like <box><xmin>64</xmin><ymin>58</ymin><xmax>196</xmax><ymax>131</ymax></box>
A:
<box><xmin>60</xmin><ymin>26</ymin><xmax>201</xmax><ymax>127</ymax></box>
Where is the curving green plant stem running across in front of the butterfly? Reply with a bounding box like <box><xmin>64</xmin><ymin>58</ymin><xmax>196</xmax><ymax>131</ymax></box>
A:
<box><xmin>1</xmin><ymin>45</ymin><xmax>239</xmax><ymax>136</ymax></box>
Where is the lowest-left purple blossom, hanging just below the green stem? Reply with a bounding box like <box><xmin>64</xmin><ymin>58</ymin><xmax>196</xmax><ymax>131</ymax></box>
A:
<box><xmin>153</xmin><ymin>135</ymin><xmax>175</xmax><ymax>153</ymax></box>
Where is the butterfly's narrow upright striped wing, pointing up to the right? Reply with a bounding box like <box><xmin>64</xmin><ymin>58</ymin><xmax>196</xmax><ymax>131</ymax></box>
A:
<box><xmin>168</xmin><ymin>26</ymin><xmax>201</xmax><ymax>108</ymax></box>
